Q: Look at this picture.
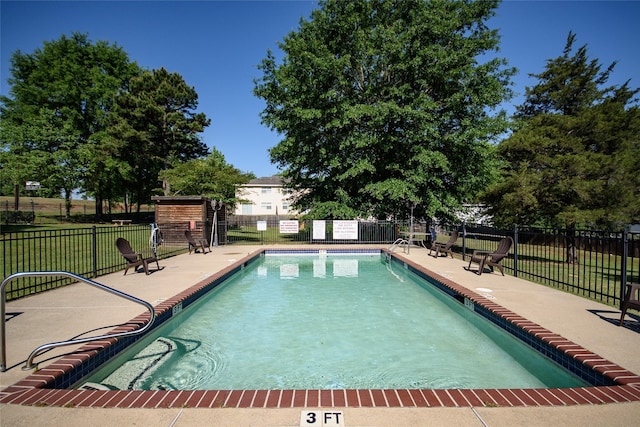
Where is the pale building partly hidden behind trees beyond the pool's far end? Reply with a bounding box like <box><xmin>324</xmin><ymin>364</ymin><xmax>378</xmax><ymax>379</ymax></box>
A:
<box><xmin>234</xmin><ymin>176</ymin><xmax>296</xmax><ymax>215</ymax></box>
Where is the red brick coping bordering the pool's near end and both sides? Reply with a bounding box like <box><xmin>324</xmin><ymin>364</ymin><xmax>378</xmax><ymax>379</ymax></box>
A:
<box><xmin>0</xmin><ymin>255</ymin><xmax>640</xmax><ymax>408</ymax></box>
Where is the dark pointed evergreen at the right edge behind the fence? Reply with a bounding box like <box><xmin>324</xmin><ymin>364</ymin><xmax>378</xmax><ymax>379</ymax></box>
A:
<box><xmin>484</xmin><ymin>33</ymin><xmax>640</xmax><ymax>232</ymax></box>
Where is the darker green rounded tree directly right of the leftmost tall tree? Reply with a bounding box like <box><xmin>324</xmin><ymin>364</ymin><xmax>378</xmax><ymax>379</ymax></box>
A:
<box><xmin>107</xmin><ymin>68</ymin><xmax>210</xmax><ymax>214</ymax></box>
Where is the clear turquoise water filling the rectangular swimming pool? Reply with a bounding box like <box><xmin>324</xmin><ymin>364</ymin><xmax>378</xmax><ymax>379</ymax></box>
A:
<box><xmin>81</xmin><ymin>254</ymin><xmax>587</xmax><ymax>390</ymax></box>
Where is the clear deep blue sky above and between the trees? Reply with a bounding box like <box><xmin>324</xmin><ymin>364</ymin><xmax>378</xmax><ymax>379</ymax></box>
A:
<box><xmin>0</xmin><ymin>0</ymin><xmax>640</xmax><ymax>177</ymax></box>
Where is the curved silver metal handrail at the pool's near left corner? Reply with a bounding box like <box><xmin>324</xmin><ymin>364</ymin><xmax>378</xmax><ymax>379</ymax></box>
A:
<box><xmin>0</xmin><ymin>271</ymin><xmax>156</xmax><ymax>372</ymax></box>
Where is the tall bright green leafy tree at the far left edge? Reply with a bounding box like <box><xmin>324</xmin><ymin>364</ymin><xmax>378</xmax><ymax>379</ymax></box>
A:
<box><xmin>0</xmin><ymin>33</ymin><xmax>138</xmax><ymax>216</ymax></box>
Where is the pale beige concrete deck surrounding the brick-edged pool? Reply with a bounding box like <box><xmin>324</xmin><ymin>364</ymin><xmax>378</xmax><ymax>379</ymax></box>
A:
<box><xmin>0</xmin><ymin>246</ymin><xmax>640</xmax><ymax>427</ymax></box>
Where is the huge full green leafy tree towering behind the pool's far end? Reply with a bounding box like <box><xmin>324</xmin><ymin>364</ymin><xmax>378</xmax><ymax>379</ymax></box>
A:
<box><xmin>254</xmin><ymin>0</ymin><xmax>514</xmax><ymax>218</ymax></box>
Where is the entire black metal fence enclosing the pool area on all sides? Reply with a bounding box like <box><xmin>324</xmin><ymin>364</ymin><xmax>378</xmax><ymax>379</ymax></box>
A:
<box><xmin>0</xmin><ymin>216</ymin><xmax>640</xmax><ymax>306</ymax></box>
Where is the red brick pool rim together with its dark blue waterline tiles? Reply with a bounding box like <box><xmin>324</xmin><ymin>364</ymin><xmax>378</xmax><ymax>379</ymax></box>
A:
<box><xmin>0</xmin><ymin>247</ymin><xmax>640</xmax><ymax>408</ymax></box>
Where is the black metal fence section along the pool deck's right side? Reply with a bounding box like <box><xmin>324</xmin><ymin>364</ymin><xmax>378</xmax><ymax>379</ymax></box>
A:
<box><xmin>455</xmin><ymin>224</ymin><xmax>640</xmax><ymax>306</ymax></box>
